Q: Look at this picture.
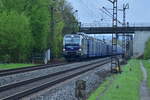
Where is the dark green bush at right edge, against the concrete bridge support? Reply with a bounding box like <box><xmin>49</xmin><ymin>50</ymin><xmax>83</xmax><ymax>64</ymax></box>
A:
<box><xmin>144</xmin><ymin>39</ymin><xmax>150</xmax><ymax>59</ymax></box>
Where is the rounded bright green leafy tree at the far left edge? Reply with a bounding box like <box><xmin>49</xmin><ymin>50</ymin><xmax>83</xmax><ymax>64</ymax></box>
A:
<box><xmin>0</xmin><ymin>11</ymin><xmax>32</xmax><ymax>62</ymax></box>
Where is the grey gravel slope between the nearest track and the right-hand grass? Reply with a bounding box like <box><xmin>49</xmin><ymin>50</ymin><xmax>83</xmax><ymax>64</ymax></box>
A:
<box><xmin>23</xmin><ymin>64</ymin><xmax>110</xmax><ymax>100</ymax></box>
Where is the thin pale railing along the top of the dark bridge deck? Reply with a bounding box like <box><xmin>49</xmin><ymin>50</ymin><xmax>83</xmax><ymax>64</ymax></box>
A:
<box><xmin>81</xmin><ymin>23</ymin><xmax>150</xmax><ymax>28</ymax></box>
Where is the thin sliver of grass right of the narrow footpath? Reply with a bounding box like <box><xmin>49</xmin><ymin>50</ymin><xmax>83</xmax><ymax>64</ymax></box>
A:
<box><xmin>143</xmin><ymin>60</ymin><xmax>150</xmax><ymax>88</ymax></box>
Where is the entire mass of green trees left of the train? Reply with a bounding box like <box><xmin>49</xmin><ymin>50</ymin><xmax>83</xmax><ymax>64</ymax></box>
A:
<box><xmin>0</xmin><ymin>0</ymin><xmax>77</xmax><ymax>62</ymax></box>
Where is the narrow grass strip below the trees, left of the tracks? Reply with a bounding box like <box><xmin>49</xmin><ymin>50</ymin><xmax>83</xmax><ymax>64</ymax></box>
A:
<box><xmin>0</xmin><ymin>64</ymin><xmax>34</xmax><ymax>70</ymax></box>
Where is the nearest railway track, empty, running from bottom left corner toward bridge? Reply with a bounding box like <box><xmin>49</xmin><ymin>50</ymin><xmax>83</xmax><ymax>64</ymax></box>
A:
<box><xmin>0</xmin><ymin>58</ymin><xmax>110</xmax><ymax>100</ymax></box>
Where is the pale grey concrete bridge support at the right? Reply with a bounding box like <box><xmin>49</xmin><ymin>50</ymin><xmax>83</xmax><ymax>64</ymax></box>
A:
<box><xmin>133</xmin><ymin>31</ymin><xmax>150</xmax><ymax>57</ymax></box>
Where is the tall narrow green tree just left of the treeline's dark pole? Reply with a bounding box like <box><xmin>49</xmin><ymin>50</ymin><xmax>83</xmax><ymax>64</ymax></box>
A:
<box><xmin>30</xmin><ymin>0</ymin><xmax>50</xmax><ymax>52</ymax></box>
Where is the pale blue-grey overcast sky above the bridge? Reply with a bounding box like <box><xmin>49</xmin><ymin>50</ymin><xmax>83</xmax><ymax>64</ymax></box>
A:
<box><xmin>67</xmin><ymin>0</ymin><xmax>150</xmax><ymax>23</ymax></box>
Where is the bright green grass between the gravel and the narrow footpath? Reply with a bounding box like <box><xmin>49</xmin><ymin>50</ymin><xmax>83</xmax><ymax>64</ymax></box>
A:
<box><xmin>88</xmin><ymin>60</ymin><xmax>142</xmax><ymax>100</ymax></box>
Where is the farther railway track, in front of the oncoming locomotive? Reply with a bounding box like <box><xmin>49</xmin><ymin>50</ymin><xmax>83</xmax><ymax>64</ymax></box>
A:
<box><xmin>0</xmin><ymin>63</ymin><xmax>67</xmax><ymax>77</ymax></box>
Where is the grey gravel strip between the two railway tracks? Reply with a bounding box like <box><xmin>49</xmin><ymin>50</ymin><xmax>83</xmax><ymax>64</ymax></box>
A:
<box><xmin>0</xmin><ymin>59</ymin><xmax>105</xmax><ymax>86</ymax></box>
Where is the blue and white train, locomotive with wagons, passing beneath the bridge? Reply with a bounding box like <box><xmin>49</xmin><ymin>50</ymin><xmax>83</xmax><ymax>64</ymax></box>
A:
<box><xmin>63</xmin><ymin>32</ymin><xmax>123</xmax><ymax>61</ymax></box>
